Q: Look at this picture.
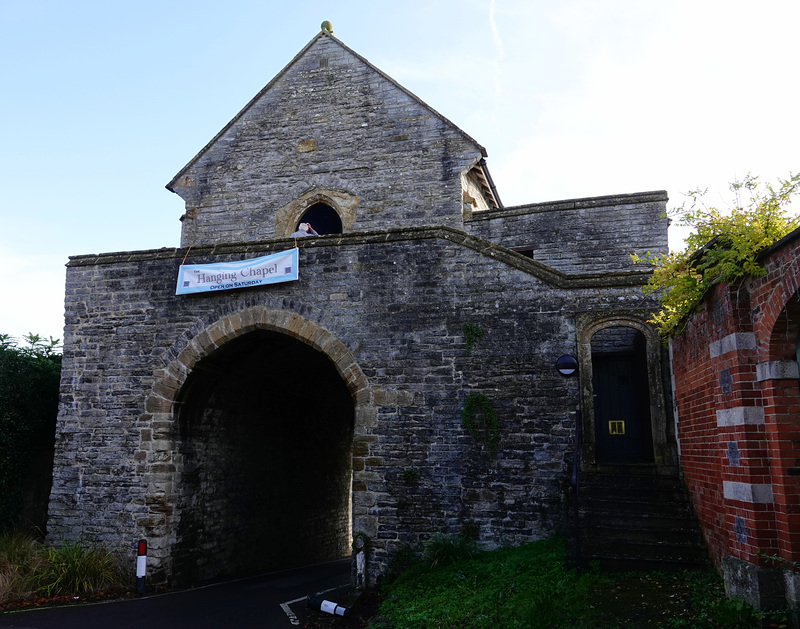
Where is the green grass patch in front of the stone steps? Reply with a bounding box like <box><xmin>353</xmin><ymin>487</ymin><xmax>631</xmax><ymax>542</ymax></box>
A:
<box><xmin>370</xmin><ymin>539</ymin><xmax>788</xmax><ymax>629</ymax></box>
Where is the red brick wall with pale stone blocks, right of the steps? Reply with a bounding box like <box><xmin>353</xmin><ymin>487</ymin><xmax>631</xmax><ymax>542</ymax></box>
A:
<box><xmin>672</xmin><ymin>235</ymin><xmax>800</xmax><ymax>565</ymax></box>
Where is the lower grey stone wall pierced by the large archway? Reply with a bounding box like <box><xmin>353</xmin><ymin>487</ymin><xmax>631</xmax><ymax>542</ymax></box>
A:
<box><xmin>48</xmin><ymin>228</ymin><xmax>652</xmax><ymax>577</ymax></box>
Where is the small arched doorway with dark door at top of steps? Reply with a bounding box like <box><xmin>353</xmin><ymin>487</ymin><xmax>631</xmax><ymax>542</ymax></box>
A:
<box><xmin>591</xmin><ymin>326</ymin><xmax>653</xmax><ymax>463</ymax></box>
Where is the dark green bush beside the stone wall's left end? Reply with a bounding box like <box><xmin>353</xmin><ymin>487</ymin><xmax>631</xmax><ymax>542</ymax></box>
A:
<box><xmin>0</xmin><ymin>334</ymin><xmax>61</xmax><ymax>528</ymax></box>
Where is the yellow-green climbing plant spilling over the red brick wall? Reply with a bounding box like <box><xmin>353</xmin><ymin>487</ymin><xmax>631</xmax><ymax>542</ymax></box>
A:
<box><xmin>631</xmin><ymin>174</ymin><xmax>800</xmax><ymax>339</ymax></box>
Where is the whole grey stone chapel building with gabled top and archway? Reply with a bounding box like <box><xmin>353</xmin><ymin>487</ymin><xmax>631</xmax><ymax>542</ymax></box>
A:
<box><xmin>48</xmin><ymin>24</ymin><xmax>677</xmax><ymax>582</ymax></box>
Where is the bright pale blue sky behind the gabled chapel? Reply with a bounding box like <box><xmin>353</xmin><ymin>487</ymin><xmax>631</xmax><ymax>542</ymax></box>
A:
<box><xmin>0</xmin><ymin>0</ymin><xmax>800</xmax><ymax>338</ymax></box>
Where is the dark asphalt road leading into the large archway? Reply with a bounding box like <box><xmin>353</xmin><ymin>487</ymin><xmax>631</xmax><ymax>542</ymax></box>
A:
<box><xmin>0</xmin><ymin>559</ymin><xmax>352</xmax><ymax>629</ymax></box>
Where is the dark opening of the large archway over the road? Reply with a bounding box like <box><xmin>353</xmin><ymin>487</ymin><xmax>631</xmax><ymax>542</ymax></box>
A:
<box><xmin>173</xmin><ymin>330</ymin><xmax>354</xmax><ymax>583</ymax></box>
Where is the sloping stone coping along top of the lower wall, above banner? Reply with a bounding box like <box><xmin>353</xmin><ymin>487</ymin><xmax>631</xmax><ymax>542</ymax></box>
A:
<box><xmin>67</xmin><ymin>226</ymin><xmax>651</xmax><ymax>289</ymax></box>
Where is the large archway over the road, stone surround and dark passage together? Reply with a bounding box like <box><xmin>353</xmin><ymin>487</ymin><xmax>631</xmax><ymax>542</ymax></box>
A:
<box><xmin>137</xmin><ymin>307</ymin><xmax>376</xmax><ymax>584</ymax></box>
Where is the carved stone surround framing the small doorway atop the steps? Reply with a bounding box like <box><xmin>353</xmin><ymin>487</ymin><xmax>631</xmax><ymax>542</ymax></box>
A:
<box><xmin>578</xmin><ymin>315</ymin><xmax>677</xmax><ymax>473</ymax></box>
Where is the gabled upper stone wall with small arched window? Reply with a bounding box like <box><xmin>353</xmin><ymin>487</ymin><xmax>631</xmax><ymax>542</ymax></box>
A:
<box><xmin>168</xmin><ymin>34</ymin><xmax>483</xmax><ymax>246</ymax></box>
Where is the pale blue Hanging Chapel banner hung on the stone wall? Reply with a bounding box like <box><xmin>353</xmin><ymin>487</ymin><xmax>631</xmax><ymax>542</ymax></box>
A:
<box><xmin>175</xmin><ymin>248</ymin><xmax>297</xmax><ymax>295</ymax></box>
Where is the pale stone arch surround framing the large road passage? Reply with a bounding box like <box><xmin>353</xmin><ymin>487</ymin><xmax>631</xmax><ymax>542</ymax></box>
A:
<box><xmin>135</xmin><ymin>306</ymin><xmax>380</xmax><ymax>580</ymax></box>
